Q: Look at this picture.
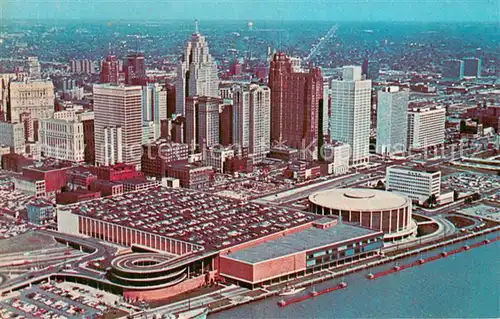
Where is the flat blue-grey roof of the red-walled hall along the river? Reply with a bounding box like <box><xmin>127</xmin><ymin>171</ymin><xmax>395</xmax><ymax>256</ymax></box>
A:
<box><xmin>227</xmin><ymin>224</ymin><xmax>382</xmax><ymax>264</ymax></box>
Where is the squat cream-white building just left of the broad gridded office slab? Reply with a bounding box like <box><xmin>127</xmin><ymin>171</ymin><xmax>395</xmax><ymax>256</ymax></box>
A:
<box><xmin>38</xmin><ymin>111</ymin><xmax>85</xmax><ymax>162</ymax></box>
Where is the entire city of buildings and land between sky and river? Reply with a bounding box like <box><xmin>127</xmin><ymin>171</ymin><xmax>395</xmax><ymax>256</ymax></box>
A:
<box><xmin>0</xmin><ymin>20</ymin><xmax>500</xmax><ymax>318</ymax></box>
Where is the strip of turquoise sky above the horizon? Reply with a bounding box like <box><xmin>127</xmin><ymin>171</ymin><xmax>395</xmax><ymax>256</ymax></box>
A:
<box><xmin>0</xmin><ymin>0</ymin><xmax>500</xmax><ymax>25</ymax></box>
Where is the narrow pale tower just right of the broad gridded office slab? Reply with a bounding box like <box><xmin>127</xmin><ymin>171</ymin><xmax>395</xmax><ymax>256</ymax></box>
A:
<box><xmin>142</xmin><ymin>83</ymin><xmax>167</xmax><ymax>141</ymax></box>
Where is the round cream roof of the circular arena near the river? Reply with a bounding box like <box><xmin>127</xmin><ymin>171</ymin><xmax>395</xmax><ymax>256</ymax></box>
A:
<box><xmin>309</xmin><ymin>188</ymin><xmax>411</xmax><ymax>211</ymax></box>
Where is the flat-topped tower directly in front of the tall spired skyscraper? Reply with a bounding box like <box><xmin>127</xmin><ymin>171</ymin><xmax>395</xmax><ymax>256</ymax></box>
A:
<box><xmin>186</xmin><ymin>96</ymin><xmax>221</xmax><ymax>152</ymax></box>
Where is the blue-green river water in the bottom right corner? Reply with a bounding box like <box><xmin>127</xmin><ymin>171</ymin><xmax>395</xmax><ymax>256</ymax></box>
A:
<box><xmin>210</xmin><ymin>239</ymin><xmax>500</xmax><ymax>318</ymax></box>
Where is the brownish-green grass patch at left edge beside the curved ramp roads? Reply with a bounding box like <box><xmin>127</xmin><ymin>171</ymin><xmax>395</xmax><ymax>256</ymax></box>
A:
<box><xmin>0</xmin><ymin>231</ymin><xmax>62</xmax><ymax>255</ymax></box>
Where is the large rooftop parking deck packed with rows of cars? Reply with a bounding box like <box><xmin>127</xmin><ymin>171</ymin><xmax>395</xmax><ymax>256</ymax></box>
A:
<box><xmin>60</xmin><ymin>187</ymin><xmax>314</xmax><ymax>250</ymax></box>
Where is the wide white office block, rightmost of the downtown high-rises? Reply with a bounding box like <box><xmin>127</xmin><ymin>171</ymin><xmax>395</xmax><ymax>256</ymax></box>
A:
<box><xmin>408</xmin><ymin>107</ymin><xmax>446</xmax><ymax>149</ymax></box>
